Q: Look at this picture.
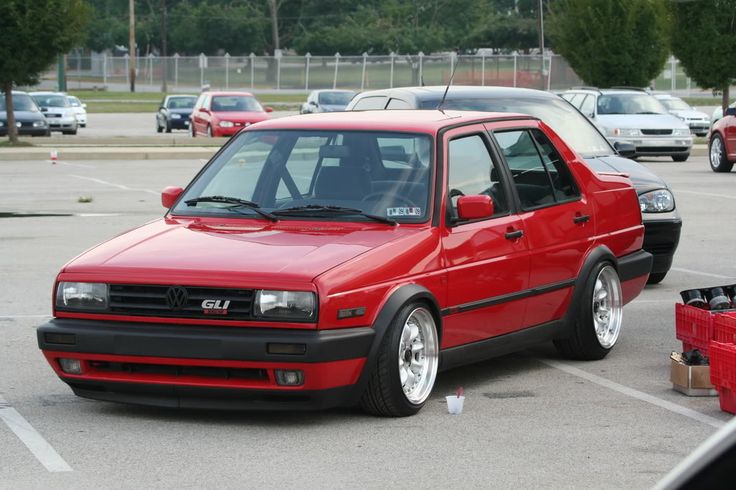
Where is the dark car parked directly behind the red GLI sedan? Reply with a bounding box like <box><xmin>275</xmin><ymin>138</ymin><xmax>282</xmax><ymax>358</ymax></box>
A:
<box><xmin>346</xmin><ymin>86</ymin><xmax>682</xmax><ymax>284</ymax></box>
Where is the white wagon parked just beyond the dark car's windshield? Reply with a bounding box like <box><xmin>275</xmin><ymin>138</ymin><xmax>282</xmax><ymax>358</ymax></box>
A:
<box><xmin>561</xmin><ymin>87</ymin><xmax>693</xmax><ymax>162</ymax></box>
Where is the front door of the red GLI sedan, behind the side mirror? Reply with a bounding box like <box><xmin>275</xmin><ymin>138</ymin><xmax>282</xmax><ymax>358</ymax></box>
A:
<box><xmin>442</xmin><ymin>124</ymin><xmax>529</xmax><ymax>348</ymax></box>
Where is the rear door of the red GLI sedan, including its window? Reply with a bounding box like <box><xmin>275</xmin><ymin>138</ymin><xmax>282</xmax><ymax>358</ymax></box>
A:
<box><xmin>493</xmin><ymin>124</ymin><xmax>595</xmax><ymax>327</ymax></box>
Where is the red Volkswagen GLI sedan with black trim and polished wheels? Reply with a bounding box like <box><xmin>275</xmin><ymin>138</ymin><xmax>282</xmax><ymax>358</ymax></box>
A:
<box><xmin>38</xmin><ymin>111</ymin><xmax>652</xmax><ymax>416</ymax></box>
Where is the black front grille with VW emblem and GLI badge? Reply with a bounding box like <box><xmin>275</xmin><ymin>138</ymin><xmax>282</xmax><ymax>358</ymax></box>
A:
<box><xmin>109</xmin><ymin>284</ymin><xmax>254</xmax><ymax>320</ymax></box>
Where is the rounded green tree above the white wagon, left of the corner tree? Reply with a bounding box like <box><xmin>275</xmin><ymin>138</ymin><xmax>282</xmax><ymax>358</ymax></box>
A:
<box><xmin>547</xmin><ymin>0</ymin><xmax>669</xmax><ymax>87</ymax></box>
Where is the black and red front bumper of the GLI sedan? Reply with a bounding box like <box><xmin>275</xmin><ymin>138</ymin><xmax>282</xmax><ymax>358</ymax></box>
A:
<box><xmin>37</xmin><ymin>319</ymin><xmax>374</xmax><ymax>409</ymax></box>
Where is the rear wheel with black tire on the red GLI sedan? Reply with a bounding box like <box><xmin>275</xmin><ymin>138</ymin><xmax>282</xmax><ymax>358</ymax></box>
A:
<box><xmin>554</xmin><ymin>262</ymin><xmax>623</xmax><ymax>361</ymax></box>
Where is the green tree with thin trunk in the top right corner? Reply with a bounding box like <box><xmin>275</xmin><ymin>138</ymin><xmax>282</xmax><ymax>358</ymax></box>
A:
<box><xmin>670</xmin><ymin>0</ymin><xmax>736</xmax><ymax>111</ymax></box>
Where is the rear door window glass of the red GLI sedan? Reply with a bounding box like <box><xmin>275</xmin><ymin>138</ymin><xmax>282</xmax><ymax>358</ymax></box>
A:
<box><xmin>494</xmin><ymin>129</ymin><xmax>580</xmax><ymax>210</ymax></box>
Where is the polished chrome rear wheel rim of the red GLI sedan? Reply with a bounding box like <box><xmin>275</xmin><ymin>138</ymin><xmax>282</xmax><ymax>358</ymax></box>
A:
<box><xmin>591</xmin><ymin>265</ymin><xmax>623</xmax><ymax>349</ymax></box>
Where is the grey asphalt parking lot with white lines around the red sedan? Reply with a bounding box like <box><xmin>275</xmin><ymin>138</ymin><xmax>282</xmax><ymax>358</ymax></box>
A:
<box><xmin>0</xmin><ymin>153</ymin><xmax>736</xmax><ymax>488</ymax></box>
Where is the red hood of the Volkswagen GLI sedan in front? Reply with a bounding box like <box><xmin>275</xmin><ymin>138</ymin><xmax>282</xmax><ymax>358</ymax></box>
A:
<box><xmin>62</xmin><ymin>218</ymin><xmax>417</xmax><ymax>287</ymax></box>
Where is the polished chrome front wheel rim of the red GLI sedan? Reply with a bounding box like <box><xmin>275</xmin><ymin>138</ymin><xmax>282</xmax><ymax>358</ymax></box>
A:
<box><xmin>398</xmin><ymin>307</ymin><xmax>439</xmax><ymax>405</ymax></box>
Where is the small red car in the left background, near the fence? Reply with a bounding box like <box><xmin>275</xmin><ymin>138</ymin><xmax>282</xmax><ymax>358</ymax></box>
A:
<box><xmin>191</xmin><ymin>92</ymin><xmax>273</xmax><ymax>137</ymax></box>
